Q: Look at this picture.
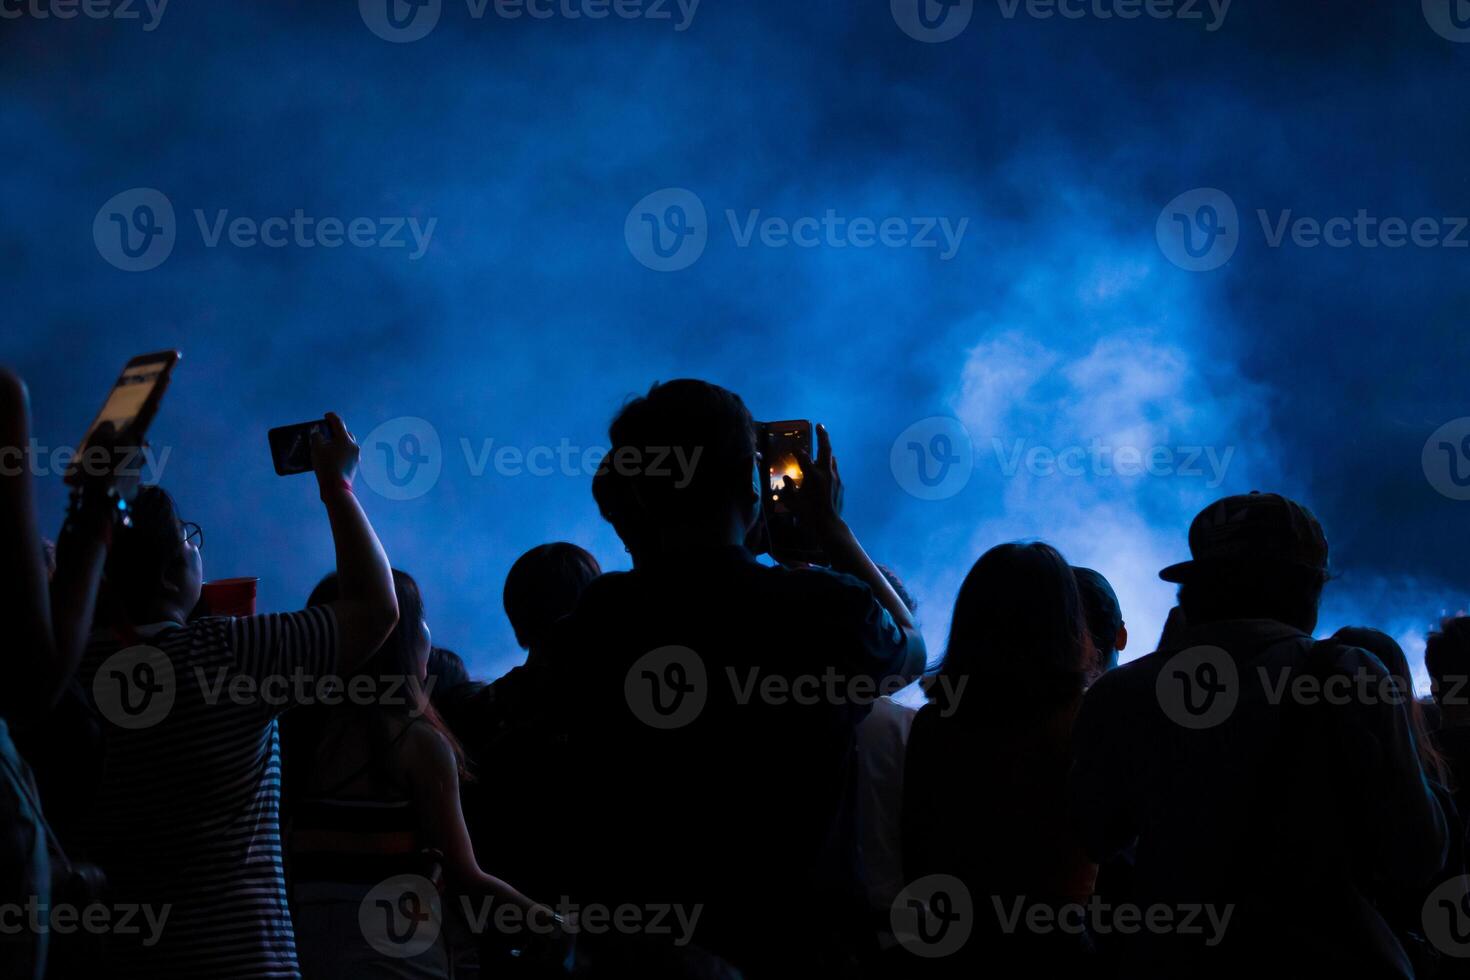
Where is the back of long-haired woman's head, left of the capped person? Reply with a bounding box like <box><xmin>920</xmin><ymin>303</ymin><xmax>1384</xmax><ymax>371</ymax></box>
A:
<box><xmin>929</xmin><ymin>542</ymin><xmax>1092</xmax><ymax>717</ymax></box>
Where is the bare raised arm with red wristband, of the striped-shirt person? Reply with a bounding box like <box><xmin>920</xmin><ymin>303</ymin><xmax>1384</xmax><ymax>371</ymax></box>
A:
<box><xmin>312</xmin><ymin>413</ymin><xmax>398</xmax><ymax>674</ymax></box>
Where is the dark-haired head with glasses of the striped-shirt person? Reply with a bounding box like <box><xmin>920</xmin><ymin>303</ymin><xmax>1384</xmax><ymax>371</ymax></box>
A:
<box><xmin>103</xmin><ymin>486</ymin><xmax>204</xmax><ymax>626</ymax></box>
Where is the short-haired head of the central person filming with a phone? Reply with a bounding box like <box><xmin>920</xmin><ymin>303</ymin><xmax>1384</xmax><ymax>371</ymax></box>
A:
<box><xmin>609</xmin><ymin>379</ymin><xmax>761</xmax><ymax>548</ymax></box>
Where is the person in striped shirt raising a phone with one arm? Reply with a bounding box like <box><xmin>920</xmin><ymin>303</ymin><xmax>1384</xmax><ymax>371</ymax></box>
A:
<box><xmin>78</xmin><ymin>414</ymin><xmax>398</xmax><ymax>980</ymax></box>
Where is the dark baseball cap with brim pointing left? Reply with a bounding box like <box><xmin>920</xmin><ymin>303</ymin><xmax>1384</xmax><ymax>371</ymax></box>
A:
<box><xmin>1158</xmin><ymin>491</ymin><xmax>1327</xmax><ymax>582</ymax></box>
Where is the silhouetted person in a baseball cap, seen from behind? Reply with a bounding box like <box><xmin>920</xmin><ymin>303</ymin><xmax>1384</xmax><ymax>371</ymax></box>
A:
<box><xmin>1070</xmin><ymin>492</ymin><xmax>1446</xmax><ymax>977</ymax></box>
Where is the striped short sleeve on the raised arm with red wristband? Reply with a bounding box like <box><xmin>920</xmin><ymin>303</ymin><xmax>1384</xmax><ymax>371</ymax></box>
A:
<box><xmin>228</xmin><ymin>605</ymin><xmax>337</xmax><ymax>710</ymax></box>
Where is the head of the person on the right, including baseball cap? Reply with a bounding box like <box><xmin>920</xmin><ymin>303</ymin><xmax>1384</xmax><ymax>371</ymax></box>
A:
<box><xmin>1158</xmin><ymin>491</ymin><xmax>1327</xmax><ymax>633</ymax></box>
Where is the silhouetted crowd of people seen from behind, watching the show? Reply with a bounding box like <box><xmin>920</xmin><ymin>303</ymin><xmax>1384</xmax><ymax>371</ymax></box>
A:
<box><xmin>0</xmin><ymin>373</ymin><xmax>1470</xmax><ymax>980</ymax></box>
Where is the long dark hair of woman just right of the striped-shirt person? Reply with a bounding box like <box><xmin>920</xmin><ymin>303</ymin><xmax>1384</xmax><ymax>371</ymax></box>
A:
<box><xmin>287</xmin><ymin>569</ymin><xmax>469</xmax><ymax>779</ymax></box>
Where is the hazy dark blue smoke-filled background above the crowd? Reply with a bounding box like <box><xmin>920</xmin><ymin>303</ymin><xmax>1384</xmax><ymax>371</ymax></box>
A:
<box><xmin>0</xmin><ymin>0</ymin><xmax>1470</xmax><ymax>687</ymax></box>
